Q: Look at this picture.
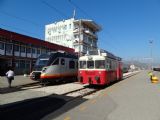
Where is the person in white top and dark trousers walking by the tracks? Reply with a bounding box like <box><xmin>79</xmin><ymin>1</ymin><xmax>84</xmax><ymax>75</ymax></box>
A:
<box><xmin>6</xmin><ymin>67</ymin><xmax>14</xmax><ymax>88</ymax></box>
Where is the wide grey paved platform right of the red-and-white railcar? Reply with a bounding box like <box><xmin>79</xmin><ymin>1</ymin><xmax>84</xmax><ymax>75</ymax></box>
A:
<box><xmin>43</xmin><ymin>71</ymin><xmax>160</xmax><ymax>120</ymax></box>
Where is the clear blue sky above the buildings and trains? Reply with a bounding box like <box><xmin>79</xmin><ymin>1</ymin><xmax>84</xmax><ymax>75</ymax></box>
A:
<box><xmin>0</xmin><ymin>0</ymin><xmax>160</xmax><ymax>62</ymax></box>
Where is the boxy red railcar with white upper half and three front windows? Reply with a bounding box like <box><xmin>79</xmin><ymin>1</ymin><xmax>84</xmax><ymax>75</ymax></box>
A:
<box><xmin>78</xmin><ymin>49</ymin><xmax>123</xmax><ymax>85</ymax></box>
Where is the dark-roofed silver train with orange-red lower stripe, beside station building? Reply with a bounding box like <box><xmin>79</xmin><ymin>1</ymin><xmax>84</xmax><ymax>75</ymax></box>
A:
<box><xmin>30</xmin><ymin>51</ymin><xmax>78</xmax><ymax>82</ymax></box>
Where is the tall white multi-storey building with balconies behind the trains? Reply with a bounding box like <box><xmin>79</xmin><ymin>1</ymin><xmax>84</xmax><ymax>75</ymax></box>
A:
<box><xmin>45</xmin><ymin>18</ymin><xmax>101</xmax><ymax>54</ymax></box>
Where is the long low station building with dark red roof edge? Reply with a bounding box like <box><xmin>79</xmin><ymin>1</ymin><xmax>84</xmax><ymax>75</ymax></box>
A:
<box><xmin>0</xmin><ymin>28</ymin><xmax>74</xmax><ymax>75</ymax></box>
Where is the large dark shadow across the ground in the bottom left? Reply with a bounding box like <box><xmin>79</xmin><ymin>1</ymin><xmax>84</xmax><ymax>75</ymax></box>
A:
<box><xmin>0</xmin><ymin>95</ymin><xmax>86</xmax><ymax>120</ymax></box>
